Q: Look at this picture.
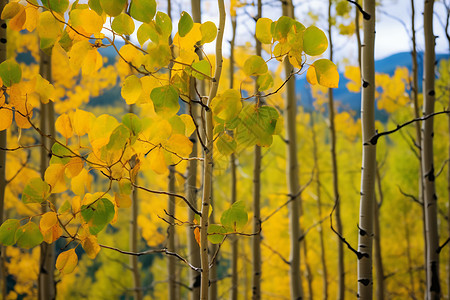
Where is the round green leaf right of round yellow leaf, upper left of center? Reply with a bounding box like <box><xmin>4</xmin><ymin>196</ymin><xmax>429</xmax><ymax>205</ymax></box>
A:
<box><xmin>150</xmin><ymin>85</ymin><xmax>180</xmax><ymax>117</ymax></box>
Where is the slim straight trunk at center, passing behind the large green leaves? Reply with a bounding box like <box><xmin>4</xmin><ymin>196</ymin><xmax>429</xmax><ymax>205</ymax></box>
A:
<box><xmin>252</xmin><ymin>0</ymin><xmax>262</xmax><ymax>300</ymax></box>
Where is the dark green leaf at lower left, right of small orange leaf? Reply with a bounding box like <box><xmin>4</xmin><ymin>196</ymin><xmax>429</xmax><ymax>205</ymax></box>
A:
<box><xmin>81</xmin><ymin>198</ymin><xmax>114</xmax><ymax>235</ymax></box>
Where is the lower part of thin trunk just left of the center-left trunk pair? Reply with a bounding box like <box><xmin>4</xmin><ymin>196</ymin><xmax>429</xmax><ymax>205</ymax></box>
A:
<box><xmin>167</xmin><ymin>165</ymin><xmax>179</xmax><ymax>300</ymax></box>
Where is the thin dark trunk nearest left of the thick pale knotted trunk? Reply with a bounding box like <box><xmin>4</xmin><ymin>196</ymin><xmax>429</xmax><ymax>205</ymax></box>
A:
<box><xmin>328</xmin><ymin>0</ymin><xmax>345</xmax><ymax>300</ymax></box>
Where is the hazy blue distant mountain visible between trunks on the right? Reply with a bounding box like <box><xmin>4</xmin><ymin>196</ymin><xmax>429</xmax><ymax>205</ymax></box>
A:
<box><xmin>296</xmin><ymin>52</ymin><xmax>450</xmax><ymax>111</ymax></box>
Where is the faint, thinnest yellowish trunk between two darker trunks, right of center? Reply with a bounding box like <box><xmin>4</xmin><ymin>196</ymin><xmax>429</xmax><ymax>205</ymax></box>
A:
<box><xmin>311</xmin><ymin>114</ymin><xmax>328</xmax><ymax>300</ymax></box>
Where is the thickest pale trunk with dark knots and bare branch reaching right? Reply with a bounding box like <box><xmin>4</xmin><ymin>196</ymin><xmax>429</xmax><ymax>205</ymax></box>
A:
<box><xmin>358</xmin><ymin>0</ymin><xmax>376</xmax><ymax>300</ymax></box>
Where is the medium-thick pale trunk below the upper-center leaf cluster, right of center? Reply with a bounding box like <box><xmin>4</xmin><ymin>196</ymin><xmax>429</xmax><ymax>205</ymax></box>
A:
<box><xmin>282</xmin><ymin>0</ymin><xmax>303</xmax><ymax>299</ymax></box>
